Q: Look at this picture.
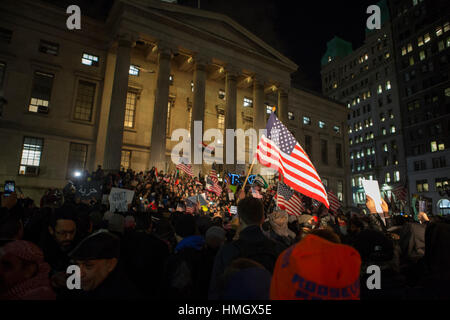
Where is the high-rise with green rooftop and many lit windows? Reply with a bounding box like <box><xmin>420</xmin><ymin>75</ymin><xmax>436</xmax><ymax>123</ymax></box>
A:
<box><xmin>321</xmin><ymin>1</ymin><xmax>406</xmax><ymax>204</ymax></box>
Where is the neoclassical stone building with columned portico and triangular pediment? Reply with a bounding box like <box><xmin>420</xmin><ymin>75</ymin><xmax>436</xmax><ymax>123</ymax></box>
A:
<box><xmin>0</xmin><ymin>0</ymin><xmax>348</xmax><ymax>205</ymax></box>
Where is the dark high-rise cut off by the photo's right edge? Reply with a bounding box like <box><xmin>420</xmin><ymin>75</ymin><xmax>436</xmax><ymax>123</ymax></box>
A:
<box><xmin>389</xmin><ymin>0</ymin><xmax>450</xmax><ymax>213</ymax></box>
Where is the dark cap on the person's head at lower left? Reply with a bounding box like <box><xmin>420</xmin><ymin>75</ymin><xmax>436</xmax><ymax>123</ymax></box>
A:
<box><xmin>69</xmin><ymin>229</ymin><xmax>120</xmax><ymax>260</ymax></box>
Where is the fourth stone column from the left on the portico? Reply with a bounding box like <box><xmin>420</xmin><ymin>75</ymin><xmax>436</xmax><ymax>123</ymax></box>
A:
<box><xmin>223</xmin><ymin>67</ymin><xmax>238</xmax><ymax>173</ymax></box>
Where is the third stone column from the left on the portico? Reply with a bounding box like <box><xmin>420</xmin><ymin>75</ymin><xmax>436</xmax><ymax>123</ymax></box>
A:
<box><xmin>191</xmin><ymin>56</ymin><xmax>207</xmax><ymax>176</ymax></box>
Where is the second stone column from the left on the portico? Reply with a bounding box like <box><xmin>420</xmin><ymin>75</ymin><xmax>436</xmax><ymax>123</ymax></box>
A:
<box><xmin>149</xmin><ymin>43</ymin><xmax>171</xmax><ymax>171</ymax></box>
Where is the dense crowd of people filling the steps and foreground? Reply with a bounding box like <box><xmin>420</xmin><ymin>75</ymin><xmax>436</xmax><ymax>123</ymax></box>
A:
<box><xmin>0</xmin><ymin>168</ymin><xmax>450</xmax><ymax>300</ymax></box>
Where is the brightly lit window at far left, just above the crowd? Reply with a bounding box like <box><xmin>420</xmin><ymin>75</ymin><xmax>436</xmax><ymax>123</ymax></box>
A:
<box><xmin>19</xmin><ymin>137</ymin><xmax>44</xmax><ymax>175</ymax></box>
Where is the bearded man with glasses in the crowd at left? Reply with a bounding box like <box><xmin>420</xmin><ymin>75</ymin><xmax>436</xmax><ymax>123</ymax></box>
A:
<box><xmin>40</xmin><ymin>205</ymin><xmax>77</xmax><ymax>289</ymax></box>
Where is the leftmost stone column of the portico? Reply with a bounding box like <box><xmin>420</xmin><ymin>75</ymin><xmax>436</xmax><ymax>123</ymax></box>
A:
<box><xmin>103</xmin><ymin>34</ymin><xmax>134</xmax><ymax>171</ymax></box>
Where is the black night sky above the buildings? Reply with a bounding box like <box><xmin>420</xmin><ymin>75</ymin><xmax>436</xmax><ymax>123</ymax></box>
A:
<box><xmin>45</xmin><ymin>0</ymin><xmax>377</xmax><ymax>92</ymax></box>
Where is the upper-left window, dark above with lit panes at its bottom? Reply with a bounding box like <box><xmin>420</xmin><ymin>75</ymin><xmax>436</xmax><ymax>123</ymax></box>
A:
<box><xmin>28</xmin><ymin>71</ymin><xmax>54</xmax><ymax>113</ymax></box>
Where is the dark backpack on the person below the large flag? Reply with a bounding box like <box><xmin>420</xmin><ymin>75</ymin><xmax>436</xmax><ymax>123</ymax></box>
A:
<box><xmin>232</xmin><ymin>237</ymin><xmax>282</xmax><ymax>273</ymax></box>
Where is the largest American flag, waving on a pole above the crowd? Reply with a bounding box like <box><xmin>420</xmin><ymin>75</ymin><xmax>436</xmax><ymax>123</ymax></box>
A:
<box><xmin>256</xmin><ymin>112</ymin><xmax>330</xmax><ymax>208</ymax></box>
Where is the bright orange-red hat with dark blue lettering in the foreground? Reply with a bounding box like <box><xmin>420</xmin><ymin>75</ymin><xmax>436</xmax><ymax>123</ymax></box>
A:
<box><xmin>270</xmin><ymin>235</ymin><xmax>361</xmax><ymax>300</ymax></box>
